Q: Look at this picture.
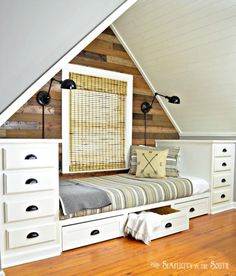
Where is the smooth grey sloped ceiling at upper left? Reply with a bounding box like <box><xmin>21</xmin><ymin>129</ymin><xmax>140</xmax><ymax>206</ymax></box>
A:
<box><xmin>0</xmin><ymin>0</ymin><xmax>126</xmax><ymax>114</ymax></box>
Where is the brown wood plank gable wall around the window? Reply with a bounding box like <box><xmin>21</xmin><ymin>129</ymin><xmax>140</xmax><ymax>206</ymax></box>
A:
<box><xmin>0</xmin><ymin>28</ymin><xmax>179</xmax><ymax>145</ymax></box>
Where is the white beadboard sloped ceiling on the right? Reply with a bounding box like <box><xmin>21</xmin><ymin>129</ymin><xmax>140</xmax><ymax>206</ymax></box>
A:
<box><xmin>113</xmin><ymin>0</ymin><xmax>236</xmax><ymax>136</ymax></box>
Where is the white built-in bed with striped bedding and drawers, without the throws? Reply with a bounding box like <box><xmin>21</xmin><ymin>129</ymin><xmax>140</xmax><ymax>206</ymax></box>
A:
<box><xmin>60</xmin><ymin>174</ymin><xmax>209</xmax><ymax>250</ymax></box>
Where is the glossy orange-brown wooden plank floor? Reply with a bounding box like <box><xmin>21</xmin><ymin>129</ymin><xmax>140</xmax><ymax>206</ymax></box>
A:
<box><xmin>5</xmin><ymin>210</ymin><xmax>236</xmax><ymax>276</ymax></box>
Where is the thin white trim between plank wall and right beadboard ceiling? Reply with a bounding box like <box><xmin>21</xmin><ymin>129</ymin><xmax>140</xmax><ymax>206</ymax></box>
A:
<box><xmin>111</xmin><ymin>24</ymin><xmax>182</xmax><ymax>135</ymax></box>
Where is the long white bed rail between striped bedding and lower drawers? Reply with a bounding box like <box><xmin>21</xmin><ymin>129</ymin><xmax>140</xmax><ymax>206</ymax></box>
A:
<box><xmin>59</xmin><ymin>192</ymin><xmax>210</xmax><ymax>226</ymax></box>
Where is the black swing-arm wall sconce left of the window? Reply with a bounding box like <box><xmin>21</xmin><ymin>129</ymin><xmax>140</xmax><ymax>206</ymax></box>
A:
<box><xmin>36</xmin><ymin>78</ymin><xmax>76</xmax><ymax>138</ymax></box>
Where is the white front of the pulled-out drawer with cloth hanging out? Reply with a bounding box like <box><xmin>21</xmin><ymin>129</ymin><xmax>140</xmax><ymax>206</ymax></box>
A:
<box><xmin>152</xmin><ymin>211</ymin><xmax>189</xmax><ymax>240</ymax></box>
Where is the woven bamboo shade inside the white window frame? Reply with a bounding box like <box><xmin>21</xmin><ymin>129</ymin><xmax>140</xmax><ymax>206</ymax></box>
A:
<box><xmin>70</xmin><ymin>73</ymin><xmax>127</xmax><ymax>172</ymax></box>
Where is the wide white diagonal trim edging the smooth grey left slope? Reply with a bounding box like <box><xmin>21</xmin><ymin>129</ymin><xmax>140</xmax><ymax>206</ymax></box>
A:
<box><xmin>0</xmin><ymin>0</ymin><xmax>137</xmax><ymax>126</ymax></box>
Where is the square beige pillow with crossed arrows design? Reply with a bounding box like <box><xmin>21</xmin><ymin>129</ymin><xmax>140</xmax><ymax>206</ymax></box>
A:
<box><xmin>136</xmin><ymin>149</ymin><xmax>168</xmax><ymax>178</ymax></box>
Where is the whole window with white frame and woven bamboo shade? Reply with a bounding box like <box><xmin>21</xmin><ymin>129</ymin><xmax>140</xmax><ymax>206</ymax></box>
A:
<box><xmin>63</xmin><ymin>65</ymin><xmax>132</xmax><ymax>173</ymax></box>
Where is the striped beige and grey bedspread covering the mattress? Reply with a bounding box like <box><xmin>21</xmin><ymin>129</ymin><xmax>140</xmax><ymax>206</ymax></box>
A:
<box><xmin>60</xmin><ymin>174</ymin><xmax>193</xmax><ymax>219</ymax></box>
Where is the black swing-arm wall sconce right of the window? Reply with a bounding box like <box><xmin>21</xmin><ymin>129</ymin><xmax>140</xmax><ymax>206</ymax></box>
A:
<box><xmin>141</xmin><ymin>92</ymin><xmax>180</xmax><ymax>146</ymax></box>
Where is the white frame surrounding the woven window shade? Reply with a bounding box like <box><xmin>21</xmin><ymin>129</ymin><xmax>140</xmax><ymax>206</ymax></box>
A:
<box><xmin>62</xmin><ymin>64</ymin><xmax>133</xmax><ymax>174</ymax></box>
